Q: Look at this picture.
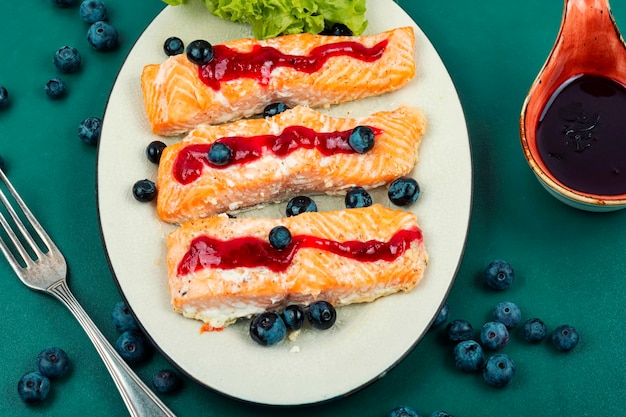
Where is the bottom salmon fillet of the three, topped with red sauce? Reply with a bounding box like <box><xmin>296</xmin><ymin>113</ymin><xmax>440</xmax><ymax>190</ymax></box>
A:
<box><xmin>167</xmin><ymin>204</ymin><xmax>428</xmax><ymax>330</ymax></box>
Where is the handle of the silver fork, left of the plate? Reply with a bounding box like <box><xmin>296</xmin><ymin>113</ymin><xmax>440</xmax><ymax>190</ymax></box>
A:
<box><xmin>47</xmin><ymin>279</ymin><xmax>175</xmax><ymax>417</ymax></box>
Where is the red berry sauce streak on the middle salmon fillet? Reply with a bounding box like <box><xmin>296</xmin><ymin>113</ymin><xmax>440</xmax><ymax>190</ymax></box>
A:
<box><xmin>173</xmin><ymin>126</ymin><xmax>381</xmax><ymax>184</ymax></box>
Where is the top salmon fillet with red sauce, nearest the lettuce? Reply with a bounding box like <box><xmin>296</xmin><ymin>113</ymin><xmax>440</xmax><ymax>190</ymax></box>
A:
<box><xmin>141</xmin><ymin>26</ymin><xmax>415</xmax><ymax>136</ymax></box>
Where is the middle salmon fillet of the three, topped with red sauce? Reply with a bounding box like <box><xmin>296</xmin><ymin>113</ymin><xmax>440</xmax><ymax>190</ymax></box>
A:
<box><xmin>157</xmin><ymin>105</ymin><xmax>427</xmax><ymax>223</ymax></box>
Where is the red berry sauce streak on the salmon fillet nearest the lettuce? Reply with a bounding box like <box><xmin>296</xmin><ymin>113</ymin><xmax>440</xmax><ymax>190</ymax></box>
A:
<box><xmin>198</xmin><ymin>40</ymin><xmax>388</xmax><ymax>90</ymax></box>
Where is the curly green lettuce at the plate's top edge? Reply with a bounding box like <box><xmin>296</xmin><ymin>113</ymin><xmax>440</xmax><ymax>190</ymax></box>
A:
<box><xmin>163</xmin><ymin>0</ymin><xmax>367</xmax><ymax>39</ymax></box>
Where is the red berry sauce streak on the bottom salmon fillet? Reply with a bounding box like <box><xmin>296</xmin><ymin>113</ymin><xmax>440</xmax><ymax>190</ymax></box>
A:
<box><xmin>177</xmin><ymin>229</ymin><xmax>422</xmax><ymax>276</ymax></box>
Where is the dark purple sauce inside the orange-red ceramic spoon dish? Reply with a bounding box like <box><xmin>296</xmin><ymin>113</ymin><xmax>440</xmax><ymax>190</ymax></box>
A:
<box><xmin>537</xmin><ymin>75</ymin><xmax>626</xmax><ymax>195</ymax></box>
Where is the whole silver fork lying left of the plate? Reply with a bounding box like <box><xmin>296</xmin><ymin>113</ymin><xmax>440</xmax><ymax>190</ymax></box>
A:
<box><xmin>0</xmin><ymin>169</ymin><xmax>175</xmax><ymax>417</ymax></box>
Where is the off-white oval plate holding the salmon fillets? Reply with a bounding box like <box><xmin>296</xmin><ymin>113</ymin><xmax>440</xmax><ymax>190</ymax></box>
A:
<box><xmin>97</xmin><ymin>0</ymin><xmax>472</xmax><ymax>405</ymax></box>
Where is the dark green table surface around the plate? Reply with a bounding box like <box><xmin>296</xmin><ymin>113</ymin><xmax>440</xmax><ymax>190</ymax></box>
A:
<box><xmin>0</xmin><ymin>0</ymin><xmax>626</xmax><ymax>417</ymax></box>
